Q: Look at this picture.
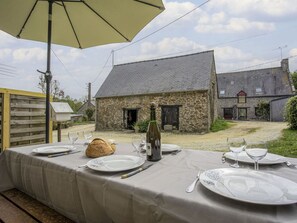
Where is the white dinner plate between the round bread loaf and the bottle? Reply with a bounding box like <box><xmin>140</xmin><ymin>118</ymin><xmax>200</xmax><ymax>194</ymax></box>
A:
<box><xmin>87</xmin><ymin>155</ymin><xmax>144</xmax><ymax>172</ymax></box>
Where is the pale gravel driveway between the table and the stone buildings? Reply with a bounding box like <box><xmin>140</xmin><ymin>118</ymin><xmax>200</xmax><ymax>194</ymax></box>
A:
<box><xmin>53</xmin><ymin>121</ymin><xmax>287</xmax><ymax>151</ymax></box>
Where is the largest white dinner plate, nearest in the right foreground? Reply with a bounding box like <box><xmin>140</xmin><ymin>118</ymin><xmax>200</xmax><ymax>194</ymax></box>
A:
<box><xmin>200</xmin><ymin>168</ymin><xmax>297</xmax><ymax>205</ymax></box>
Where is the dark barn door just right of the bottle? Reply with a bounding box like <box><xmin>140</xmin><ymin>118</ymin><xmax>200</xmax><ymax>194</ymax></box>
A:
<box><xmin>162</xmin><ymin>106</ymin><xmax>179</xmax><ymax>130</ymax></box>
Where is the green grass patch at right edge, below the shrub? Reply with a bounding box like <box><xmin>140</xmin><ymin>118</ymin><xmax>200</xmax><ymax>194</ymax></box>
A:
<box><xmin>268</xmin><ymin>129</ymin><xmax>297</xmax><ymax>158</ymax></box>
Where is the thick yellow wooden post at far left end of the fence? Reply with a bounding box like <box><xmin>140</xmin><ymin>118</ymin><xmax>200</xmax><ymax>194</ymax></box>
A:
<box><xmin>1</xmin><ymin>92</ymin><xmax>10</xmax><ymax>150</ymax></box>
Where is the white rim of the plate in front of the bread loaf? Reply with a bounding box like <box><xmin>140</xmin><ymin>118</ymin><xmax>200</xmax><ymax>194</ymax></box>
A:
<box><xmin>86</xmin><ymin>155</ymin><xmax>145</xmax><ymax>172</ymax></box>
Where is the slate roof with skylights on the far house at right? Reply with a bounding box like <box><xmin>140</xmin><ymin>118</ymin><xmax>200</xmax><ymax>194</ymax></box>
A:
<box><xmin>217</xmin><ymin>67</ymin><xmax>293</xmax><ymax>97</ymax></box>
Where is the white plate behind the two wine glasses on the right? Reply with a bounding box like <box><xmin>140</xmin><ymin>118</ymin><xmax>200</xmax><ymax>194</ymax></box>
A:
<box><xmin>224</xmin><ymin>151</ymin><xmax>286</xmax><ymax>165</ymax></box>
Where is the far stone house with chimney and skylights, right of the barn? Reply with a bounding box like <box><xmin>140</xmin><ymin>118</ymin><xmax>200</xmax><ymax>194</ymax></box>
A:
<box><xmin>217</xmin><ymin>59</ymin><xmax>295</xmax><ymax>121</ymax></box>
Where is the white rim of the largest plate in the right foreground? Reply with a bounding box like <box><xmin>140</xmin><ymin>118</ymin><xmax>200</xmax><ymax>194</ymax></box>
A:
<box><xmin>200</xmin><ymin>168</ymin><xmax>297</xmax><ymax>205</ymax></box>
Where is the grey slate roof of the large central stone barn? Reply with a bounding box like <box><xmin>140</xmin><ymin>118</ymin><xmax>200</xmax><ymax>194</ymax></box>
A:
<box><xmin>95</xmin><ymin>51</ymin><xmax>214</xmax><ymax>98</ymax></box>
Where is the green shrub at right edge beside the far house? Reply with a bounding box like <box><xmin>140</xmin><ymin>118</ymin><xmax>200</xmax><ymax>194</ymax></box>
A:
<box><xmin>285</xmin><ymin>96</ymin><xmax>297</xmax><ymax>130</ymax></box>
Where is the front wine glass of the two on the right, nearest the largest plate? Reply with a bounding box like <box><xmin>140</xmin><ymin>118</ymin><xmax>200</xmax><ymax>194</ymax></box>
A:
<box><xmin>245</xmin><ymin>142</ymin><xmax>268</xmax><ymax>170</ymax></box>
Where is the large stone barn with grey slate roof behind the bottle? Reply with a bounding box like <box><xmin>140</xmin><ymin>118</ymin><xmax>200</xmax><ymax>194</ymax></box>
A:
<box><xmin>95</xmin><ymin>51</ymin><xmax>217</xmax><ymax>132</ymax></box>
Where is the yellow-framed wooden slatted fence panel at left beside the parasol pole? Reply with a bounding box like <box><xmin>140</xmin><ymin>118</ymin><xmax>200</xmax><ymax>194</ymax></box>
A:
<box><xmin>0</xmin><ymin>88</ymin><xmax>52</xmax><ymax>151</ymax></box>
